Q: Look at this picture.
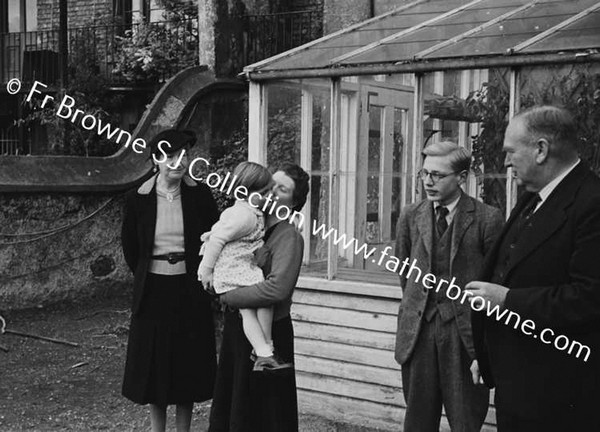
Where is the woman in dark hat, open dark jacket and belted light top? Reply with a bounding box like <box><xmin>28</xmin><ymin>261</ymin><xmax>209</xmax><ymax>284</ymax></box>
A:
<box><xmin>122</xmin><ymin>130</ymin><xmax>219</xmax><ymax>431</ymax></box>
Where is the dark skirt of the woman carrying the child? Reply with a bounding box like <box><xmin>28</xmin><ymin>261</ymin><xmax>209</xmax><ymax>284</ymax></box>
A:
<box><xmin>209</xmin><ymin>312</ymin><xmax>298</xmax><ymax>432</ymax></box>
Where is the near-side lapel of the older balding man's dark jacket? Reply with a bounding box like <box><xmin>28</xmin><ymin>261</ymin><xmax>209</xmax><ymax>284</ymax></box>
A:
<box><xmin>505</xmin><ymin>162</ymin><xmax>587</xmax><ymax>280</ymax></box>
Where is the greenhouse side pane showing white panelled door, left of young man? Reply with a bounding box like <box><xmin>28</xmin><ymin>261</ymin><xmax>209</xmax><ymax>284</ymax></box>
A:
<box><xmin>336</xmin><ymin>75</ymin><xmax>414</xmax><ymax>285</ymax></box>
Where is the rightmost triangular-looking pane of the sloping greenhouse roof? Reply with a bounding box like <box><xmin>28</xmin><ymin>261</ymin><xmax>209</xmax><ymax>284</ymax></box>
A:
<box><xmin>522</xmin><ymin>11</ymin><xmax>600</xmax><ymax>52</ymax></box>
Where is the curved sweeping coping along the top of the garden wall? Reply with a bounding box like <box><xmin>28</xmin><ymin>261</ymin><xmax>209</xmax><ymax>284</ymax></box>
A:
<box><xmin>0</xmin><ymin>66</ymin><xmax>246</xmax><ymax>192</ymax></box>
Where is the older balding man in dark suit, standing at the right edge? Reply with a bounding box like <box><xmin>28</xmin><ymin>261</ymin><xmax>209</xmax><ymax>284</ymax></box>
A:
<box><xmin>467</xmin><ymin>106</ymin><xmax>600</xmax><ymax>432</ymax></box>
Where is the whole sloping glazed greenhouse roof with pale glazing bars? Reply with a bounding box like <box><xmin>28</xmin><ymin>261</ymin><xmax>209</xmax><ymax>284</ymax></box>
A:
<box><xmin>244</xmin><ymin>0</ymin><xmax>600</xmax><ymax>80</ymax></box>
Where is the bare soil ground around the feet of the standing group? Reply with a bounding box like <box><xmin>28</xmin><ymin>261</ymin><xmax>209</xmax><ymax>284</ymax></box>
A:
<box><xmin>0</xmin><ymin>297</ymin><xmax>382</xmax><ymax>432</ymax></box>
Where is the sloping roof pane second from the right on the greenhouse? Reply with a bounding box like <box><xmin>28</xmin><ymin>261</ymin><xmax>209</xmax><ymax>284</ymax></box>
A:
<box><xmin>425</xmin><ymin>0</ymin><xmax>597</xmax><ymax>58</ymax></box>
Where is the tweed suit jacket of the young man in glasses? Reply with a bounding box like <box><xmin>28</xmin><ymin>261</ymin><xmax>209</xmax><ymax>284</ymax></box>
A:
<box><xmin>395</xmin><ymin>193</ymin><xmax>504</xmax><ymax>364</ymax></box>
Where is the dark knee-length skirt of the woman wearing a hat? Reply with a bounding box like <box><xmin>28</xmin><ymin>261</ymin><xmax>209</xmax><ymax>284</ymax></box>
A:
<box><xmin>123</xmin><ymin>273</ymin><xmax>216</xmax><ymax>405</ymax></box>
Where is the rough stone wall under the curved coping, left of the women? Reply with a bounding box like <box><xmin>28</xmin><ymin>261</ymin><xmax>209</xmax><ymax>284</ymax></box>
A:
<box><xmin>0</xmin><ymin>193</ymin><xmax>132</xmax><ymax>309</ymax></box>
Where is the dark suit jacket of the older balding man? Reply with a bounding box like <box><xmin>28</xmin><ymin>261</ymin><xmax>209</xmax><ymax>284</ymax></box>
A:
<box><xmin>473</xmin><ymin>162</ymin><xmax>600</xmax><ymax>431</ymax></box>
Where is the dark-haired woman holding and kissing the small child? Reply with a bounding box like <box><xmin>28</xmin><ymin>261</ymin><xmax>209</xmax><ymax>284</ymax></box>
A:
<box><xmin>209</xmin><ymin>164</ymin><xmax>309</xmax><ymax>432</ymax></box>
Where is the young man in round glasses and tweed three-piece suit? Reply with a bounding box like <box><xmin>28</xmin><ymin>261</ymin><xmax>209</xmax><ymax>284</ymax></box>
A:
<box><xmin>396</xmin><ymin>142</ymin><xmax>504</xmax><ymax>432</ymax></box>
